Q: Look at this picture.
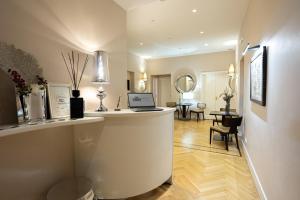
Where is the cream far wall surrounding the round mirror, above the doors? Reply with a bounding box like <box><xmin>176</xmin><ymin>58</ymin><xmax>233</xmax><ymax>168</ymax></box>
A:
<box><xmin>146</xmin><ymin>51</ymin><xmax>235</xmax><ymax>104</ymax></box>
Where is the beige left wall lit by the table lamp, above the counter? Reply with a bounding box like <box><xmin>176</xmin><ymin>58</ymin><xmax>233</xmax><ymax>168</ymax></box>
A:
<box><xmin>0</xmin><ymin>0</ymin><xmax>127</xmax><ymax>110</ymax></box>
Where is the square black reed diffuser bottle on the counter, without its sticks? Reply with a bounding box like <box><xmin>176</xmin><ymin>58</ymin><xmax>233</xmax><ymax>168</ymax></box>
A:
<box><xmin>70</xmin><ymin>90</ymin><xmax>84</xmax><ymax>119</ymax></box>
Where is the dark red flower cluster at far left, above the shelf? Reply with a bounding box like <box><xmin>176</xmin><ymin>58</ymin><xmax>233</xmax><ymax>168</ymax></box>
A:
<box><xmin>8</xmin><ymin>69</ymin><xmax>32</xmax><ymax>96</ymax></box>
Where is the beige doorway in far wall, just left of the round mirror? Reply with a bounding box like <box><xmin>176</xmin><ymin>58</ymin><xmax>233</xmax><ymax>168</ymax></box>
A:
<box><xmin>152</xmin><ymin>74</ymin><xmax>171</xmax><ymax>107</ymax></box>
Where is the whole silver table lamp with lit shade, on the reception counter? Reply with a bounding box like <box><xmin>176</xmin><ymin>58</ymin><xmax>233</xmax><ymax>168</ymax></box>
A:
<box><xmin>93</xmin><ymin>51</ymin><xmax>110</xmax><ymax>112</ymax></box>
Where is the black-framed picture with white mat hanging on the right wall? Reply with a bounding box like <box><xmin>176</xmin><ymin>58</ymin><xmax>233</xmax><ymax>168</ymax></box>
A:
<box><xmin>250</xmin><ymin>46</ymin><xmax>267</xmax><ymax>106</ymax></box>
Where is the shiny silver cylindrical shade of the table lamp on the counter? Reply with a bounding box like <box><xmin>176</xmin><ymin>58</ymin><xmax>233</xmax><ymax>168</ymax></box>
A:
<box><xmin>94</xmin><ymin>51</ymin><xmax>109</xmax><ymax>83</ymax></box>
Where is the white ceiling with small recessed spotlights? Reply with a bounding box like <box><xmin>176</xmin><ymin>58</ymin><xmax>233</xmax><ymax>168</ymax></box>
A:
<box><xmin>115</xmin><ymin>0</ymin><xmax>248</xmax><ymax>59</ymax></box>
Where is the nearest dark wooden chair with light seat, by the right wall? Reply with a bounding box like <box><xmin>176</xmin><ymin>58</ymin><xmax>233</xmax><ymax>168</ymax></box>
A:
<box><xmin>209</xmin><ymin>116</ymin><xmax>243</xmax><ymax>156</ymax></box>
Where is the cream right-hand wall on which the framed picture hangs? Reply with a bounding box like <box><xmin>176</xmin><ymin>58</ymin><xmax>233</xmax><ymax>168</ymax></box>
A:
<box><xmin>238</xmin><ymin>0</ymin><xmax>300</xmax><ymax>200</ymax></box>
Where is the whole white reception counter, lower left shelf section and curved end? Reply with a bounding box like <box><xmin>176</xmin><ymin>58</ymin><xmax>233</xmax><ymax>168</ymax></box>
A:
<box><xmin>0</xmin><ymin>108</ymin><xmax>175</xmax><ymax>200</ymax></box>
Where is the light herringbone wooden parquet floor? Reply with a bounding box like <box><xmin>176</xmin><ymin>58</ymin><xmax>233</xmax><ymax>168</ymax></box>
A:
<box><xmin>129</xmin><ymin>120</ymin><xmax>259</xmax><ymax>200</ymax></box>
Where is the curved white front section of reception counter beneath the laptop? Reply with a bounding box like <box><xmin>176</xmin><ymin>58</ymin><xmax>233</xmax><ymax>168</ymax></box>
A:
<box><xmin>74</xmin><ymin>108</ymin><xmax>175</xmax><ymax>199</ymax></box>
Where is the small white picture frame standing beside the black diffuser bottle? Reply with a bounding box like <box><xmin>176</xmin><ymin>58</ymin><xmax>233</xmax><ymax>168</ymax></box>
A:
<box><xmin>47</xmin><ymin>83</ymin><xmax>72</xmax><ymax>118</ymax></box>
